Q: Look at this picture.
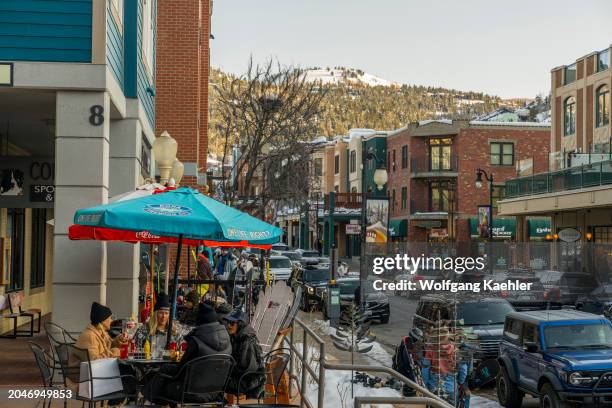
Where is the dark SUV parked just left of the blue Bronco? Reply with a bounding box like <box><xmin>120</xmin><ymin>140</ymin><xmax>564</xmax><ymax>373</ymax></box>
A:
<box><xmin>412</xmin><ymin>294</ymin><xmax>514</xmax><ymax>361</ymax></box>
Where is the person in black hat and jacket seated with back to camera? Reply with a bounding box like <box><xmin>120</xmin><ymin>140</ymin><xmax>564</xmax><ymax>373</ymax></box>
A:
<box><xmin>144</xmin><ymin>304</ymin><xmax>232</xmax><ymax>404</ymax></box>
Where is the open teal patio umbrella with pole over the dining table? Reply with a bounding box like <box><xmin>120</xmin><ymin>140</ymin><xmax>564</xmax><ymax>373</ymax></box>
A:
<box><xmin>74</xmin><ymin>187</ymin><xmax>283</xmax><ymax>340</ymax></box>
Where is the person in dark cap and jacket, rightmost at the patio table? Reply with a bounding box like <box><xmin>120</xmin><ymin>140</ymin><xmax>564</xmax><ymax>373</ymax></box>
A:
<box><xmin>225</xmin><ymin>310</ymin><xmax>266</xmax><ymax>398</ymax></box>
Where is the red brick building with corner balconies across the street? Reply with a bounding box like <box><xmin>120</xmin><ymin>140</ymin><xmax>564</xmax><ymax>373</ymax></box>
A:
<box><xmin>387</xmin><ymin>120</ymin><xmax>550</xmax><ymax>241</ymax></box>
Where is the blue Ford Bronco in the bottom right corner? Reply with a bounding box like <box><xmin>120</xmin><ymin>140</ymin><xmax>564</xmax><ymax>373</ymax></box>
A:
<box><xmin>497</xmin><ymin>310</ymin><xmax>612</xmax><ymax>408</ymax></box>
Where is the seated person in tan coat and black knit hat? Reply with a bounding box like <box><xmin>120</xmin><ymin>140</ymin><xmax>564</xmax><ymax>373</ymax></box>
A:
<box><xmin>75</xmin><ymin>302</ymin><xmax>127</xmax><ymax>360</ymax></box>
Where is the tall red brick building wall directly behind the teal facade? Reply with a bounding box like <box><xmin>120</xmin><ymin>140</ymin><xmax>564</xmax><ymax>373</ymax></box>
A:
<box><xmin>155</xmin><ymin>0</ymin><xmax>212</xmax><ymax>187</ymax></box>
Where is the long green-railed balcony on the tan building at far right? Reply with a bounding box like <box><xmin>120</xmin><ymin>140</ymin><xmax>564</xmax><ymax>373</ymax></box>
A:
<box><xmin>505</xmin><ymin>160</ymin><xmax>612</xmax><ymax>198</ymax></box>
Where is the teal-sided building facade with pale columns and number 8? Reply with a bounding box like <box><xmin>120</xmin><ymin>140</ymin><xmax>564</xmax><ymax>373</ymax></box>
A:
<box><xmin>0</xmin><ymin>0</ymin><xmax>157</xmax><ymax>331</ymax></box>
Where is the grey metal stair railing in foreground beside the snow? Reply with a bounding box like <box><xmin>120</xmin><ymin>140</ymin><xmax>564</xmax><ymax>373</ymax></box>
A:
<box><xmin>284</xmin><ymin>317</ymin><xmax>453</xmax><ymax>408</ymax></box>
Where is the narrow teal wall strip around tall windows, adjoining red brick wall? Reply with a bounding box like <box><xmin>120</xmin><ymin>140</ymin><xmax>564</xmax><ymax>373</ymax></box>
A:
<box><xmin>136</xmin><ymin>0</ymin><xmax>157</xmax><ymax>129</ymax></box>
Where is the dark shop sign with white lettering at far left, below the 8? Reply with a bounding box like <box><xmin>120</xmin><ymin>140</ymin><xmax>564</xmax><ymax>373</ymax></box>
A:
<box><xmin>0</xmin><ymin>156</ymin><xmax>55</xmax><ymax>208</ymax></box>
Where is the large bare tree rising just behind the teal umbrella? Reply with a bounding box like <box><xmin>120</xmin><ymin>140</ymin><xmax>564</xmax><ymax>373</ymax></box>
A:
<box><xmin>212</xmin><ymin>58</ymin><xmax>325</xmax><ymax>217</ymax></box>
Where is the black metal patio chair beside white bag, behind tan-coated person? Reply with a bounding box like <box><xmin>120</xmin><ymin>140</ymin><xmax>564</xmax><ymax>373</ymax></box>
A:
<box><xmin>55</xmin><ymin>343</ymin><xmax>138</xmax><ymax>407</ymax></box>
